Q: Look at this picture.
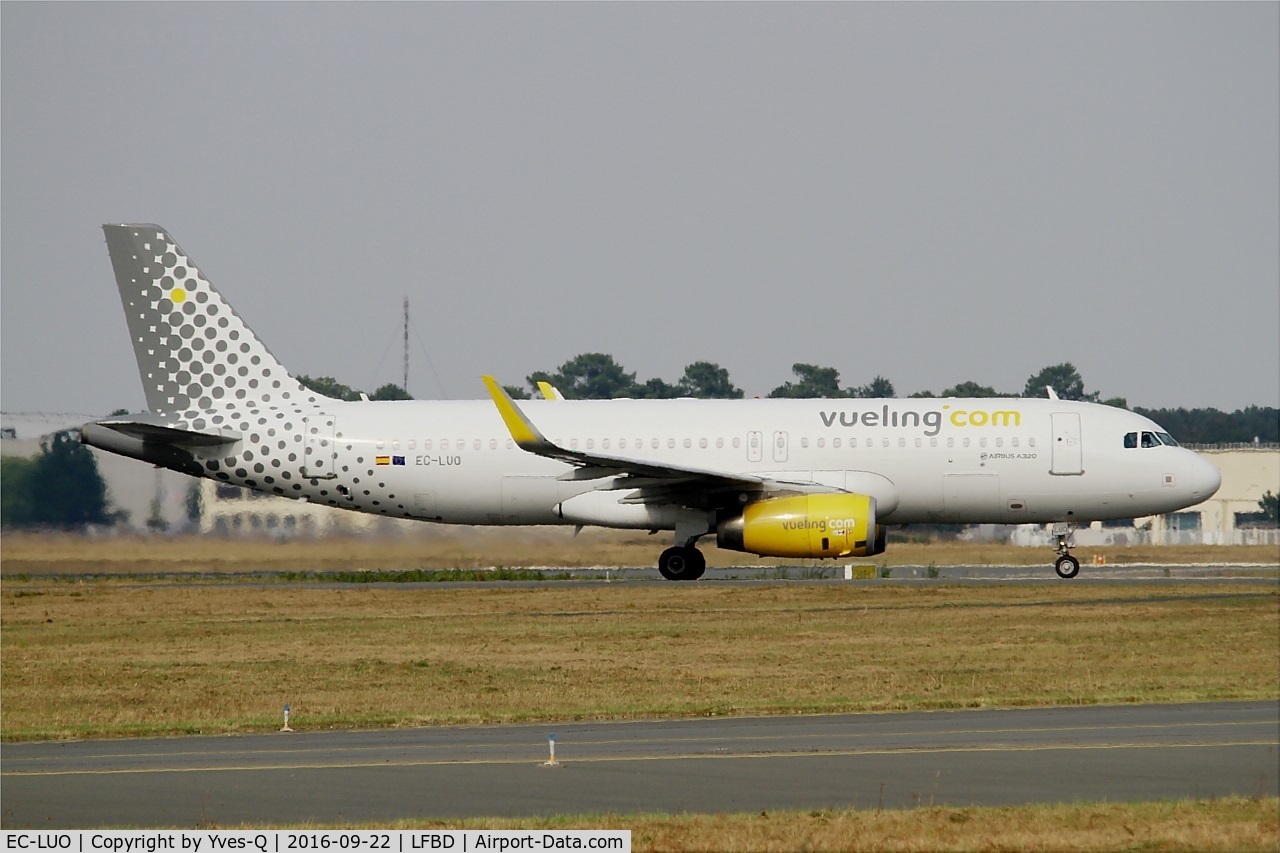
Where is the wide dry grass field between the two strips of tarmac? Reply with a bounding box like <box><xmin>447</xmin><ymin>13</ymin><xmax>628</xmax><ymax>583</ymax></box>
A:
<box><xmin>0</xmin><ymin>578</ymin><xmax>1280</xmax><ymax>739</ymax></box>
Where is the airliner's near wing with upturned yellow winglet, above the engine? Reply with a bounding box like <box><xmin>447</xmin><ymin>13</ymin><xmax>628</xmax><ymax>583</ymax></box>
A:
<box><xmin>484</xmin><ymin>375</ymin><xmax>842</xmax><ymax>506</ymax></box>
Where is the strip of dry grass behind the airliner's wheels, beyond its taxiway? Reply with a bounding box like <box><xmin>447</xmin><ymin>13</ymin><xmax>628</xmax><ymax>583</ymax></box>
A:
<box><xmin>0</xmin><ymin>525</ymin><xmax>1280</xmax><ymax>576</ymax></box>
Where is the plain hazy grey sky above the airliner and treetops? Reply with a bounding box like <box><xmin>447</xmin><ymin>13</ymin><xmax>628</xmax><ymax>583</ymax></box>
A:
<box><xmin>0</xmin><ymin>3</ymin><xmax>1280</xmax><ymax>412</ymax></box>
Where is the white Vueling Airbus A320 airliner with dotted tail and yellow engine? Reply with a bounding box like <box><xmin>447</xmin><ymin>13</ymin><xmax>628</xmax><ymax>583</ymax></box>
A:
<box><xmin>81</xmin><ymin>224</ymin><xmax>1221</xmax><ymax>580</ymax></box>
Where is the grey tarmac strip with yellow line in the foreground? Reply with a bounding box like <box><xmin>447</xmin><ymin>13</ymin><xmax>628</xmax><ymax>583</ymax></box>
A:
<box><xmin>0</xmin><ymin>701</ymin><xmax>1280</xmax><ymax>829</ymax></box>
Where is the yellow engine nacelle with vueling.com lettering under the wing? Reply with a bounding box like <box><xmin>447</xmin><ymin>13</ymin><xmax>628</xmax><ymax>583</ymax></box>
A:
<box><xmin>716</xmin><ymin>493</ymin><xmax>884</xmax><ymax>557</ymax></box>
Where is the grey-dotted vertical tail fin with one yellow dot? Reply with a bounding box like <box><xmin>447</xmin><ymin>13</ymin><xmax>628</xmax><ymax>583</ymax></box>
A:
<box><xmin>102</xmin><ymin>224</ymin><xmax>321</xmax><ymax>412</ymax></box>
